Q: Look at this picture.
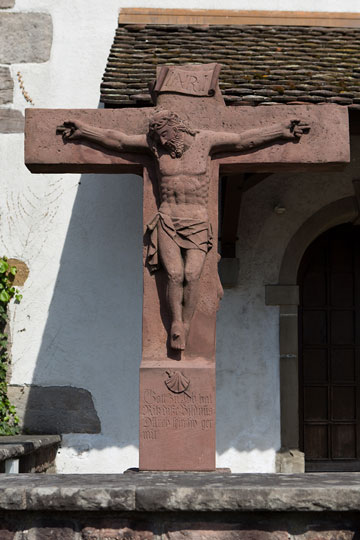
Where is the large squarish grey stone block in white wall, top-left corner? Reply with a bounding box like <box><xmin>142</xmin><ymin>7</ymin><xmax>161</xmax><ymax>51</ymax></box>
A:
<box><xmin>0</xmin><ymin>12</ymin><xmax>52</xmax><ymax>64</ymax></box>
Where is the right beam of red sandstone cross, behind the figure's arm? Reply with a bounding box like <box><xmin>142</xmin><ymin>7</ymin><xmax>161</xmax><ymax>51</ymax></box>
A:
<box><xmin>213</xmin><ymin>104</ymin><xmax>350</xmax><ymax>175</ymax></box>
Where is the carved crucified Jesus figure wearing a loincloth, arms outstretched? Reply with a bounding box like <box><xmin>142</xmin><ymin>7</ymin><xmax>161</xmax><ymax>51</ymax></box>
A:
<box><xmin>61</xmin><ymin>110</ymin><xmax>310</xmax><ymax>350</ymax></box>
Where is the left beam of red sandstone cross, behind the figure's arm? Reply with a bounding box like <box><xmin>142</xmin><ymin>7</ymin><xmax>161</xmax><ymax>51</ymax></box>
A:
<box><xmin>25</xmin><ymin>109</ymin><xmax>152</xmax><ymax>174</ymax></box>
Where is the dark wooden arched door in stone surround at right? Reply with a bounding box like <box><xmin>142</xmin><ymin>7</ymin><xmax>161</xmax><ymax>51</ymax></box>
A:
<box><xmin>298</xmin><ymin>224</ymin><xmax>360</xmax><ymax>471</ymax></box>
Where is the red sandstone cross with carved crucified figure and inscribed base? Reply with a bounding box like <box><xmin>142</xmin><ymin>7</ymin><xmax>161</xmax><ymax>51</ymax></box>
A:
<box><xmin>26</xmin><ymin>64</ymin><xmax>349</xmax><ymax>470</ymax></box>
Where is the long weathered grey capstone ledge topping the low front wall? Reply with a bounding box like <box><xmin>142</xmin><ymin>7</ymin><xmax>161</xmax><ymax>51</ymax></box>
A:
<box><xmin>0</xmin><ymin>473</ymin><xmax>360</xmax><ymax>513</ymax></box>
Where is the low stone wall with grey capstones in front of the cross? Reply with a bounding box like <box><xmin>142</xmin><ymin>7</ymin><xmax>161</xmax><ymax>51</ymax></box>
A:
<box><xmin>0</xmin><ymin>472</ymin><xmax>360</xmax><ymax>540</ymax></box>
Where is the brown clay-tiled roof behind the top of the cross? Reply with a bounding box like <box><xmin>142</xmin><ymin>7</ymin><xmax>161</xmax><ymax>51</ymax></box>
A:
<box><xmin>101</xmin><ymin>24</ymin><xmax>360</xmax><ymax>108</ymax></box>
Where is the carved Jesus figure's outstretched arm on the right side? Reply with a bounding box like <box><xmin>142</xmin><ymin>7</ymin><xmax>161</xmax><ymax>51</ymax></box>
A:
<box><xmin>211</xmin><ymin>119</ymin><xmax>310</xmax><ymax>152</ymax></box>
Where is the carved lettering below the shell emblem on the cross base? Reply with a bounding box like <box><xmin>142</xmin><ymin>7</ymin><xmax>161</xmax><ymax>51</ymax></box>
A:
<box><xmin>141</xmin><ymin>388</ymin><xmax>215</xmax><ymax>440</ymax></box>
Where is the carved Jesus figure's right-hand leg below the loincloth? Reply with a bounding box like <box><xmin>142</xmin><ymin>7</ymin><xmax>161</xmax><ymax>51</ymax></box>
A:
<box><xmin>183</xmin><ymin>249</ymin><xmax>206</xmax><ymax>337</ymax></box>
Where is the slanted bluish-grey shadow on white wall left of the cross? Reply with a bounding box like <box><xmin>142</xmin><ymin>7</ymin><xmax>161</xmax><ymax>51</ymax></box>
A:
<box><xmin>24</xmin><ymin>174</ymin><xmax>142</xmax><ymax>447</ymax></box>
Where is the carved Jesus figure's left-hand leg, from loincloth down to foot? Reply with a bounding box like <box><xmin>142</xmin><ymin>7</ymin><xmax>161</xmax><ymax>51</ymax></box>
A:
<box><xmin>158</xmin><ymin>226</ymin><xmax>185</xmax><ymax>349</ymax></box>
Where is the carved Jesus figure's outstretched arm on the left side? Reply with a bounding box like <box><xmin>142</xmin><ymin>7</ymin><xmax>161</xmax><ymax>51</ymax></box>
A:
<box><xmin>58</xmin><ymin>120</ymin><xmax>149</xmax><ymax>152</ymax></box>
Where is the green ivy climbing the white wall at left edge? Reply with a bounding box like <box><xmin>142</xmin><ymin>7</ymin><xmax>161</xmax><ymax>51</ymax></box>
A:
<box><xmin>0</xmin><ymin>257</ymin><xmax>22</xmax><ymax>435</ymax></box>
